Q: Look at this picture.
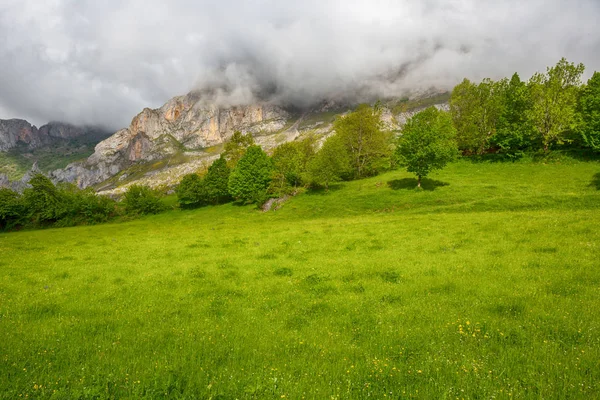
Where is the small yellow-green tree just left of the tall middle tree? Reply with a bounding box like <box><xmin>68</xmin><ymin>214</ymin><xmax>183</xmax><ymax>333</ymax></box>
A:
<box><xmin>308</xmin><ymin>135</ymin><xmax>350</xmax><ymax>190</ymax></box>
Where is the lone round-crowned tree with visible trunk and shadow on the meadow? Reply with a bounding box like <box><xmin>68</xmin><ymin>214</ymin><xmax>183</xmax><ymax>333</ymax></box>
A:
<box><xmin>396</xmin><ymin>107</ymin><xmax>458</xmax><ymax>187</ymax></box>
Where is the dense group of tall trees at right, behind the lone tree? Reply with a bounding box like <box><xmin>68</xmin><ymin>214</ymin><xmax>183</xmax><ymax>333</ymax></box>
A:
<box><xmin>450</xmin><ymin>58</ymin><xmax>600</xmax><ymax>157</ymax></box>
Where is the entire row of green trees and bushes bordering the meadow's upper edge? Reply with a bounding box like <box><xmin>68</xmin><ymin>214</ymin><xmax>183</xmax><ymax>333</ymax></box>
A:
<box><xmin>0</xmin><ymin>58</ymin><xmax>600</xmax><ymax>230</ymax></box>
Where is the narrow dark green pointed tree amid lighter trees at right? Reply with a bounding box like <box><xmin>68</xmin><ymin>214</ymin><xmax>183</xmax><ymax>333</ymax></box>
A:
<box><xmin>492</xmin><ymin>73</ymin><xmax>535</xmax><ymax>157</ymax></box>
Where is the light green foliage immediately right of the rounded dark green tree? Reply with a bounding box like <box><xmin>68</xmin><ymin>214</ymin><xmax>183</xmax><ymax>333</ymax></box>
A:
<box><xmin>272</xmin><ymin>137</ymin><xmax>315</xmax><ymax>194</ymax></box>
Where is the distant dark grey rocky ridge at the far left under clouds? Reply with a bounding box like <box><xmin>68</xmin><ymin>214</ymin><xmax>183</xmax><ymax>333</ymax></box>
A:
<box><xmin>0</xmin><ymin>119</ymin><xmax>87</xmax><ymax>151</ymax></box>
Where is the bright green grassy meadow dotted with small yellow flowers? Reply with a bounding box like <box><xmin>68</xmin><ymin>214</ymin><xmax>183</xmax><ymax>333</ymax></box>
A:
<box><xmin>0</xmin><ymin>161</ymin><xmax>600</xmax><ymax>399</ymax></box>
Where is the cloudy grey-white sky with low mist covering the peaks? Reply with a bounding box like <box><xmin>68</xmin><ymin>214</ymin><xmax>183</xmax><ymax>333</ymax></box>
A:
<box><xmin>0</xmin><ymin>0</ymin><xmax>600</xmax><ymax>130</ymax></box>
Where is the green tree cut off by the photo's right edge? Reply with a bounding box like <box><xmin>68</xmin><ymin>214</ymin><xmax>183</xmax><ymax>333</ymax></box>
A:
<box><xmin>578</xmin><ymin>72</ymin><xmax>600</xmax><ymax>151</ymax></box>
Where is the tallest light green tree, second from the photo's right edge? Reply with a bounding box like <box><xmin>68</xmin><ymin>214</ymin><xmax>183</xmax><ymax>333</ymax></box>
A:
<box><xmin>528</xmin><ymin>58</ymin><xmax>585</xmax><ymax>152</ymax></box>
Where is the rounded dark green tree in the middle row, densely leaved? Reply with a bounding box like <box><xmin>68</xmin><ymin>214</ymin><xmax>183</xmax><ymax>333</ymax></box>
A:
<box><xmin>228</xmin><ymin>146</ymin><xmax>273</xmax><ymax>203</ymax></box>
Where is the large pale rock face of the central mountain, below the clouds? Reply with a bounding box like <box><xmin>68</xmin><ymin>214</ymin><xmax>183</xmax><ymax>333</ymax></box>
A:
<box><xmin>51</xmin><ymin>93</ymin><xmax>291</xmax><ymax>187</ymax></box>
